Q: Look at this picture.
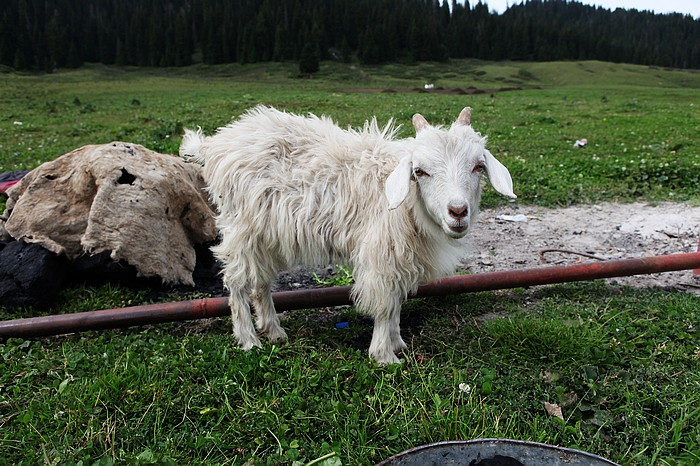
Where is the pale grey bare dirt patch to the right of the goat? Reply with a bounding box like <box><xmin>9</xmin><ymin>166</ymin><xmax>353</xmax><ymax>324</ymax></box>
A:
<box><xmin>463</xmin><ymin>203</ymin><xmax>700</xmax><ymax>295</ymax></box>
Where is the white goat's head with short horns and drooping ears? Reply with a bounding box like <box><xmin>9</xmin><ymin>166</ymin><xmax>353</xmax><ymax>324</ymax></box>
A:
<box><xmin>385</xmin><ymin>107</ymin><xmax>516</xmax><ymax>238</ymax></box>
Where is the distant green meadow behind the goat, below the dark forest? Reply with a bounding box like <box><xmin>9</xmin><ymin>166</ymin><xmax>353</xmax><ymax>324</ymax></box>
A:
<box><xmin>0</xmin><ymin>61</ymin><xmax>700</xmax><ymax>210</ymax></box>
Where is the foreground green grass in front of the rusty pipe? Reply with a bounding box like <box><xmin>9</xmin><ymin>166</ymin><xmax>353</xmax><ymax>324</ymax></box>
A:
<box><xmin>0</xmin><ymin>284</ymin><xmax>700</xmax><ymax>464</ymax></box>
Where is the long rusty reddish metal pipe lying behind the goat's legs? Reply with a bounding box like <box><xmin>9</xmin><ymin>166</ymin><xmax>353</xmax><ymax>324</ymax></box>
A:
<box><xmin>0</xmin><ymin>252</ymin><xmax>700</xmax><ymax>338</ymax></box>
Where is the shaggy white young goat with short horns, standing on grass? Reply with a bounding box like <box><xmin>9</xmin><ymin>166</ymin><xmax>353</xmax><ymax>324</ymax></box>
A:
<box><xmin>180</xmin><ymin>106</ymin><xmax>515</xmax><ymax>363</ymax></box>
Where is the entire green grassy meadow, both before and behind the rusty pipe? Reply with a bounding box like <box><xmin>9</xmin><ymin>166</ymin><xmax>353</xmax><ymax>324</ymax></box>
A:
<box><xmin>0</xmin><ymin>61</ymin><xmax>700</xmax><ymax>466</ymax></box>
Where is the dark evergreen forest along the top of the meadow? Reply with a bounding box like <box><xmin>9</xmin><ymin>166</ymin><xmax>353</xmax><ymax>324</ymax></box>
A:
<box><xmin>0</xmin><ymin>0</ymin><xmax>700</xmax><ymax>71</ymax></box>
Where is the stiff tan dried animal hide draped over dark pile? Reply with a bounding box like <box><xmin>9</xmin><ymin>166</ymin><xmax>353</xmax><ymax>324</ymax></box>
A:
<box><xmin>0</xmin><ymin>142</ymin><xmax>216</xmax><ymax>285</ymax></box>
